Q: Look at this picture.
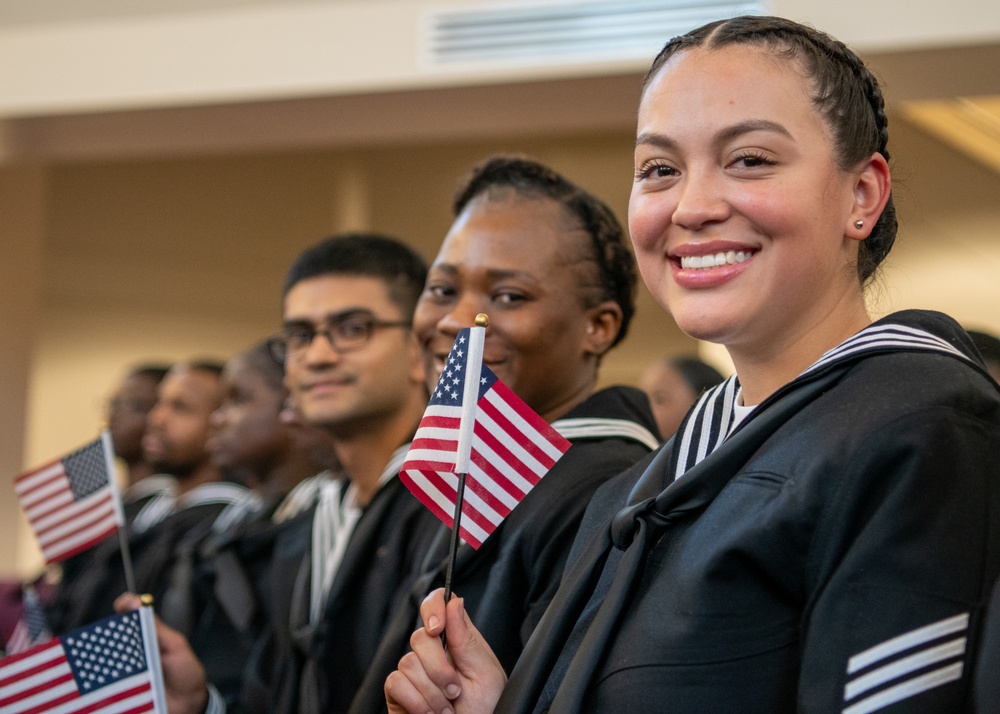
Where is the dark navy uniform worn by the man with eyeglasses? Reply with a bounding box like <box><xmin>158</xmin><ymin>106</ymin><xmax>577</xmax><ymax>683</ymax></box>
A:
<box><xmin>241</xmin><ymin>456</ymin><xmax>438</xmax><ymax>714</ymax></box>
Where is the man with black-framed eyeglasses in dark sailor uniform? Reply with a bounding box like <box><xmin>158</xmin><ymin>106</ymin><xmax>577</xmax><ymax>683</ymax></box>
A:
<box><xmin>232</xmin><ymin>234</ymin><xmax>434</xmax><ymax>714</ymax></box>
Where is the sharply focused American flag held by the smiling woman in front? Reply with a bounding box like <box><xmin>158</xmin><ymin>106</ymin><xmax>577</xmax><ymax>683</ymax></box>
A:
<box><xmin>399</xmin><ymin>328</ymin><xmax>570</xmax><ymax>549</ymax></box>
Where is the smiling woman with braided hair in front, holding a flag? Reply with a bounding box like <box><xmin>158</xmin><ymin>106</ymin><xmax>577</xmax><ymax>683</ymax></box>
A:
<box><xmin>386</xmin><ymin>17</ymin><xmax>1000</xmax><ymax>714</ymax></box>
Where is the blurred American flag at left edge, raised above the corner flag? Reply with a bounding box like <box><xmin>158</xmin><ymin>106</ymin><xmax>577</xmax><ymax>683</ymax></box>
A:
<box><xmin>14</xmin><ymin>432</ymin><xmax>124</xmax><ymax>563</ymax></box>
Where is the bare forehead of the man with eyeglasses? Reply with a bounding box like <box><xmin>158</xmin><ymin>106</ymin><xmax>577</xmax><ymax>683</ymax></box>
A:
<box><xmin>284</xmin><ymin>275</ymin><xmax>398</xmax><ymax>321</ymax></box>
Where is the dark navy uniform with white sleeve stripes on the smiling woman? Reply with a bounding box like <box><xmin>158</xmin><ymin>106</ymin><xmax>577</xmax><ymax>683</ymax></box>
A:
<box><xmin>496</xmin><ymin>311</ymin><xmax>1000</xmax><ymax>714</ymax></box>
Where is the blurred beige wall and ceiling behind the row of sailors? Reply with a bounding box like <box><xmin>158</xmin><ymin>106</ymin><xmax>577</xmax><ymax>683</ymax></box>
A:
<box><xmin>0</xmin><ymin>0</ymin><xmax>1000</xmax><ymax>576</ymax></box>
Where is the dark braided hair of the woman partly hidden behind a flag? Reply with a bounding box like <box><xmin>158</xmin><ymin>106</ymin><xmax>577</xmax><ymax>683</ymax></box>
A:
<box><xmin>452</xmin><ymin>155</ymin><xmax>637</xmax><ymax>347</ymax></box>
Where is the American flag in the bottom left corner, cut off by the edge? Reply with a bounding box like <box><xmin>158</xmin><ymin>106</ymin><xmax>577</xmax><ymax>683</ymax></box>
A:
<box><xmin>0</xmin><ymin>608</ymin><xmax>166</xmax><ymax>714</ymax></box>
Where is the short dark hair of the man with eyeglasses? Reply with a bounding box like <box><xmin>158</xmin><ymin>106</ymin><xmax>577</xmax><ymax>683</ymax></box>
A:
<box><xmin>282</xmin><ymin>233</ymin><xmax>427</xmax><ymax>316</ymax></box>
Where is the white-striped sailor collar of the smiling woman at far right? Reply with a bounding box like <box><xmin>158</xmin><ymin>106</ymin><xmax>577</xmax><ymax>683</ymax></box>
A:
<box><xmin>671</xmin><ymin>322</ymin><xmax>975</xmax><ymax>480</ymax></box>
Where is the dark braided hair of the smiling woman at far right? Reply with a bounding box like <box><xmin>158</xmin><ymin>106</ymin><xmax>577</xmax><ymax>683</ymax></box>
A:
<box><xmin>642</xmin><ymin>16</ymin><xmax>897</xmax><ymax>285</ymax></box>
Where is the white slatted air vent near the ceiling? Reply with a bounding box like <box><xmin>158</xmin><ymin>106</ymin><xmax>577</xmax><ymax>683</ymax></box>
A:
<box><xmin>421</xmin><ymin>0</ymin><xmax>763</xmax><ymax>69</ymax></box>
